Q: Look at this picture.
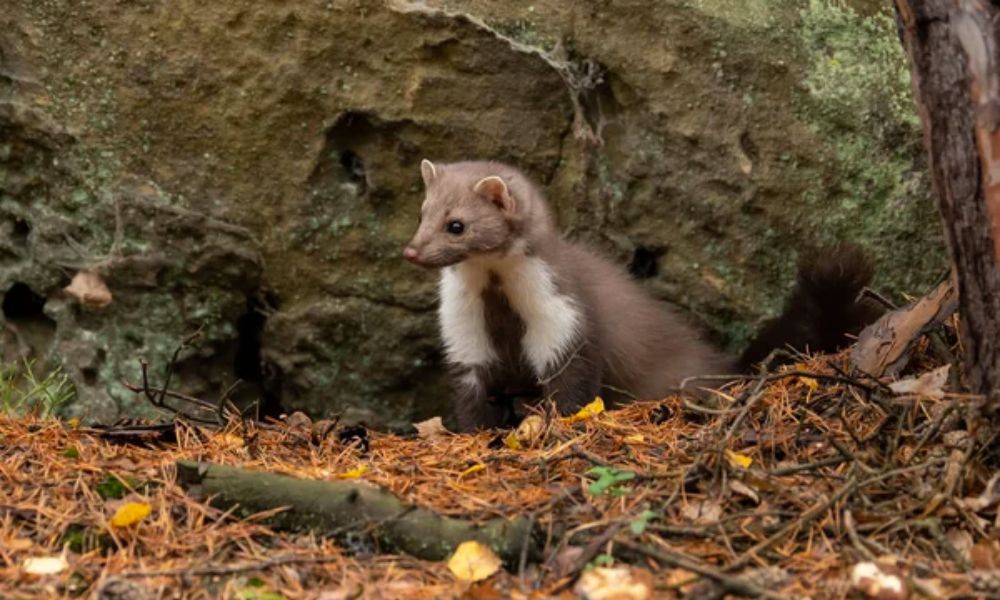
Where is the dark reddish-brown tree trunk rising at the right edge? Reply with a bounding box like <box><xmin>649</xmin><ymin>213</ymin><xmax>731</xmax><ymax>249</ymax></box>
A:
<box><xmin>895</xmin><ymin>0</ymin><xmax>1000</xmax><ymax>400</ymax></box>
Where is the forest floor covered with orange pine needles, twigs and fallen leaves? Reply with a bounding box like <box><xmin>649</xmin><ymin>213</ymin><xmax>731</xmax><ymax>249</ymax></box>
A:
<box><xmin>0</xmin><ymin>342</ymin><xmax>1000</xmax><ymax>600</ymax></box>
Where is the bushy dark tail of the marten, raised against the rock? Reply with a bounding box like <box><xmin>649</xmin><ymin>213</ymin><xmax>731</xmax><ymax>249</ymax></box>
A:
<box><xmin>740</xmin><ymin>244</ymin><xmax>884</xmax><ymax>369</ymax></box>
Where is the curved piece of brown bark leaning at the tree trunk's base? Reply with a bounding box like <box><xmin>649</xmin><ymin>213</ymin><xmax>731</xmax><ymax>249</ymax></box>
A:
<box><xmin>851</xmin><ymin>278</ymin><xmax>958</xmax><ymax>377</ymax></box>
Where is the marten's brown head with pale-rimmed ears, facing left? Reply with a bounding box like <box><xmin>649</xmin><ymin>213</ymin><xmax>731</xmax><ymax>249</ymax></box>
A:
<box><xmin>403</xmin><ymin>160</ymin><xmax>526</xmax><ymax>267</ymax></box>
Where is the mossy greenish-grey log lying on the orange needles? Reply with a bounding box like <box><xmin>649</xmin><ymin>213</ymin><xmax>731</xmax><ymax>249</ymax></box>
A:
<box><xmin>177</xmin><ymin>460</ymin><xmax>537</xmax><ymax>567</ymax></box>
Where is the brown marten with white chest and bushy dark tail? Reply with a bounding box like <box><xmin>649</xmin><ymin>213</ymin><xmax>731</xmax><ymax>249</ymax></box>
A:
<box><xmin>403</xmin><ymin>160</ymin><xmax>874</xmax><ymax>431</ymax></box>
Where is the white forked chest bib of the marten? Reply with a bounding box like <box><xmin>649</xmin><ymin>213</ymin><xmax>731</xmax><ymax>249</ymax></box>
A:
<box><xmin>438</xmin><ymin>256</ymin><xmax>583</xmax><ymax>378</ymax></box>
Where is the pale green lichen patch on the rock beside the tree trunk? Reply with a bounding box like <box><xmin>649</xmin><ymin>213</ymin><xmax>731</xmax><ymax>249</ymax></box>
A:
<box><xmin>798</xmin><ymin>0</ymin><xmax>946</xmax><ymax>292</ymax></box>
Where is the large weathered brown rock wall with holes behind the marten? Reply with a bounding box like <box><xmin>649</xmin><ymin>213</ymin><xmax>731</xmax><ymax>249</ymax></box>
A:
<box><xmin>0</xmin><ymin>0</ymin><xmax>945</xmax><ymax>427</ymax></box>
